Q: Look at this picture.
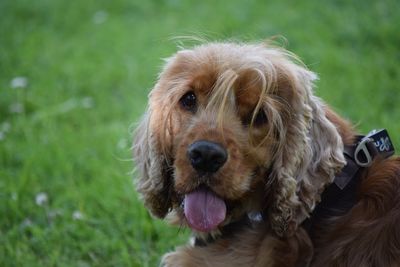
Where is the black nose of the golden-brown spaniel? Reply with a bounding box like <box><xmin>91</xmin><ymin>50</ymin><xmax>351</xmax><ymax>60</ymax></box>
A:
<box><xmin>187</xmin><ymin>140</ymin><xmax>228</xmax><ymax>173</ymax></box>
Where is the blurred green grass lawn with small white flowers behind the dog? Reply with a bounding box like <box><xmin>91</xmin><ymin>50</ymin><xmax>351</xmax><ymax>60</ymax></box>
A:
<box><xmin>0</xmin><ymin>0</ymin><xmax>400</xmax><ymax>267</ymax></box>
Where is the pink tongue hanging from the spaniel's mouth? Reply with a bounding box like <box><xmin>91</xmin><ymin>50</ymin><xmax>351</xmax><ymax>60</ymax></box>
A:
<box><xmin>184</xmin><ymin>189</ymin><xmax>226</xmax><ymax>232</ymax></box>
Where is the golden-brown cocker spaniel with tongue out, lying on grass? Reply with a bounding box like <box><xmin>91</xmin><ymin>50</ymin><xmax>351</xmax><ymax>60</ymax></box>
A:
<box><xmin>134</xmin><ymin>42</ymin><xmax>400</xmax><ymax>267</ymax></box>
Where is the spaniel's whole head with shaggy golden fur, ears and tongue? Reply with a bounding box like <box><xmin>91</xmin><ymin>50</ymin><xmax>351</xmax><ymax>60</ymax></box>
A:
<box><xmin>135</xmin><ymin>43</ymin><xmax>344</xmax><ymax>235</ymax></box>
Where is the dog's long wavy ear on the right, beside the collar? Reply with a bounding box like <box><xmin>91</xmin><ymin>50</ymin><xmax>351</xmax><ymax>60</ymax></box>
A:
<box><xmin>269</xmin><ymin>58</ymin><xmax>345</xmax><ymax>236</ymax></box>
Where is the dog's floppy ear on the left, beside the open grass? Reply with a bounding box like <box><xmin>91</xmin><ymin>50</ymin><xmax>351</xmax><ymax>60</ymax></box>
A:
<box><xmin>134</xmin><ymin>108</ymin><xmax>171</xmax><ymax>218</ymax></box>
